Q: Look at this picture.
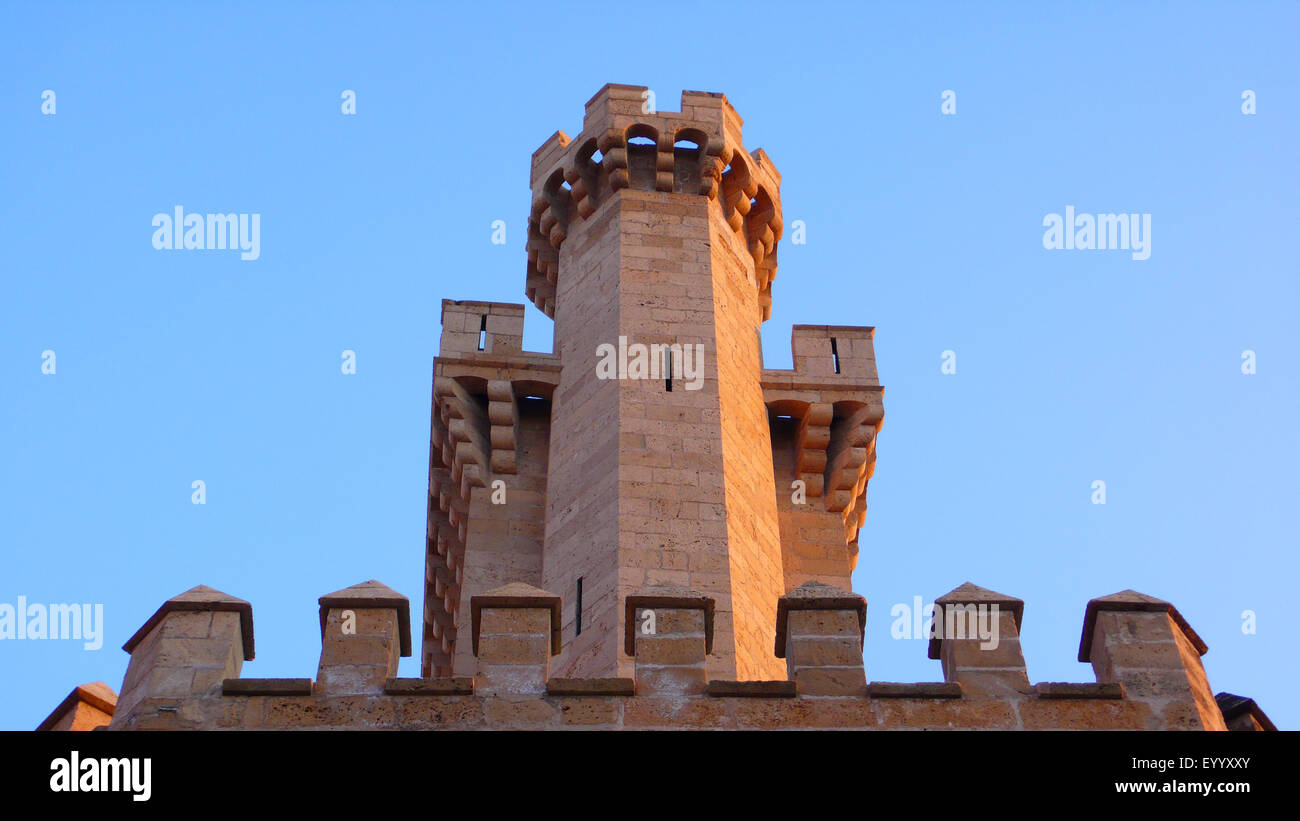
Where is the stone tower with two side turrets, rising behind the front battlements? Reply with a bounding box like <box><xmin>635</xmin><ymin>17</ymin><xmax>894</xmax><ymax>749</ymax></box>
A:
<box><xmin>423</xmin><ymin>84</ymin><xmax>883</xmax><ymax>679</ymax></box>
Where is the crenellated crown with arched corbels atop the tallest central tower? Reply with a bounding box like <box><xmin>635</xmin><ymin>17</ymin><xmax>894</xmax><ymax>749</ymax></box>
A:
<box><xmin>525</xmin><ymin>83</ymin><xmax>783</xmax><ymax>320</ymax></box>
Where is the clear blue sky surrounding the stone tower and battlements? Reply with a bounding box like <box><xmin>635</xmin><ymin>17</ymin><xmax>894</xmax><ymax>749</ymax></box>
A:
<box><xmin>0</xmin><ymin>3</ymin><xmax>1300</xmax><ymax>729</ymax></box>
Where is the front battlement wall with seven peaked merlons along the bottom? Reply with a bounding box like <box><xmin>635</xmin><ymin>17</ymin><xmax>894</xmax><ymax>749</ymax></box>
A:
<box><xmin>101</xmin><ymin>581</ymin><xmax>1271</xmax><ymax>730</ymax></box>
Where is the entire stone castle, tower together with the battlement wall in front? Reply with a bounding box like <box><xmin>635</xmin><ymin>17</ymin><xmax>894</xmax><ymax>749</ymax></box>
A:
<box><xmin>81</xmin><ymin>86</ymin><xmax>1273</xmax><ymax>730</ymax></box>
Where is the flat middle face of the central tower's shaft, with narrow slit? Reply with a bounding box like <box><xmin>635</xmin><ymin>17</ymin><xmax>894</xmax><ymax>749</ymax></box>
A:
<box><xmin>611</xmin><ymin>190</ymin><xmax>736</xmax><ymax>676</ymax></box>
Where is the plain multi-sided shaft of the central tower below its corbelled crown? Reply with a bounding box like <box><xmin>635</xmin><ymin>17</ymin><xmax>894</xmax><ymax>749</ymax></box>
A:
<box><xmin>542</xmin><ymin>184</ymin><xmax>784</xmax><ymax>678</ymax></box>
